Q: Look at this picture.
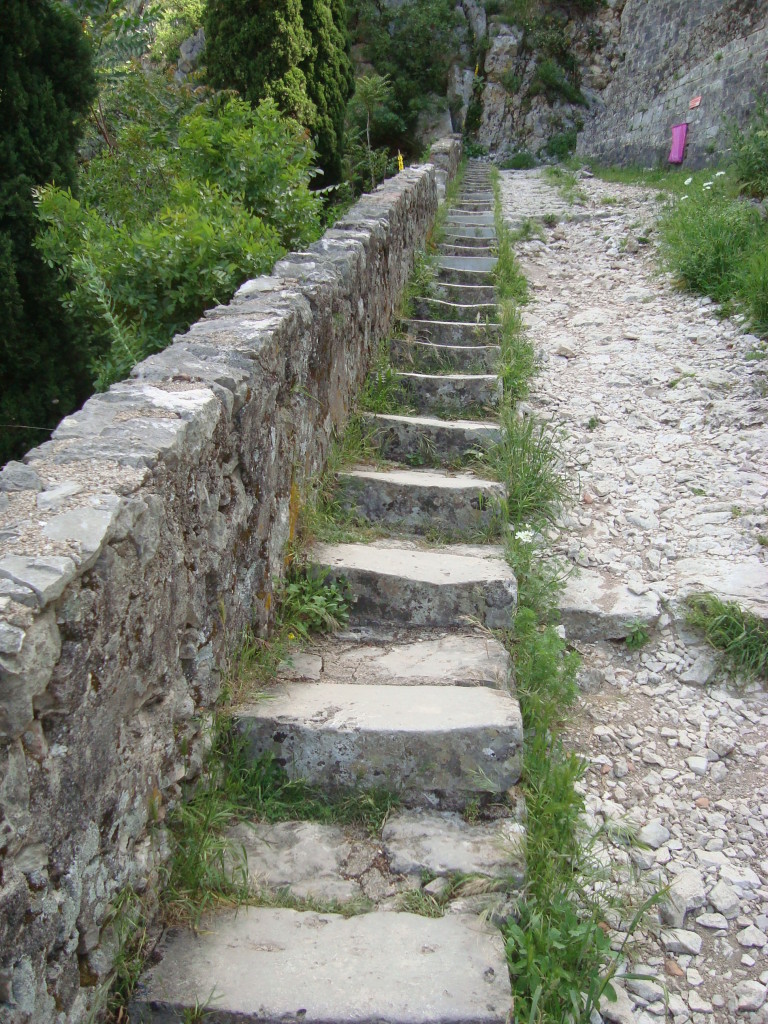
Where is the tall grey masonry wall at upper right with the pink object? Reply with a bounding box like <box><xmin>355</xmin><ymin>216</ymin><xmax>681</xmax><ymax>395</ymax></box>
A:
<box><xmin>578</xmin><ymin>0</ymin><xmax>768</xmax><ymax>168</ymax></box>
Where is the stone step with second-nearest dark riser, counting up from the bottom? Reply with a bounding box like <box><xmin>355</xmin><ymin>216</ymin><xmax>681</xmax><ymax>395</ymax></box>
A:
<box><xmin>310</xmin><ymin>541</ymin><xmax>517</xmax><ymax>629</ymax></box>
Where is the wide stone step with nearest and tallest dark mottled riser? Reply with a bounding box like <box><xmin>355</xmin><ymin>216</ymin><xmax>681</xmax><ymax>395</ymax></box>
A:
<box><xmin>231</xmin><ymin>683</ymin><xmax>522</xmax><ymax>798</ymax></box>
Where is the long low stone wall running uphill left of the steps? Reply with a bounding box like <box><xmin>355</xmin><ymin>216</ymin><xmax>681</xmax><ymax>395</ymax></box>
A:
<box><xmin>0</xmin><ymin>139</ymin><xmax>461</xmax><ymax>1024</ymax></box>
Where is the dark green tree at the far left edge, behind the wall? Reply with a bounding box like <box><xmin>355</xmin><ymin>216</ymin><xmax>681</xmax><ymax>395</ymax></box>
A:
<box><xmin>0</xmin><ymin>0</ymin><xmax>95</xmax><ymax>463</ymax></box>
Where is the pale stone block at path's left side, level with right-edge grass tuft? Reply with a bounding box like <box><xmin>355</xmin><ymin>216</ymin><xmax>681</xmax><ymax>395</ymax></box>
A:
<box><xmin>560</xmin><ymin>569</ymin><xmax>662</xmax><ymax>641</ymax></box>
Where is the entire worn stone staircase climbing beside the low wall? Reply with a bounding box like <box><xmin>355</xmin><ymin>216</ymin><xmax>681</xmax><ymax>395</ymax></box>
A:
<box><xmin>131</xmin><ymin>165</ymin><xmax>523</xmax><ymax>1024</ymax></box>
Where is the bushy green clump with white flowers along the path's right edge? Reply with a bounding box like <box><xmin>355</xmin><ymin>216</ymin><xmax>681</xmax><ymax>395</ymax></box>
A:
<box><xmin>659</xmin><ymin>188</ymin><xmax>759</xmax><ymax>302</ymax></box>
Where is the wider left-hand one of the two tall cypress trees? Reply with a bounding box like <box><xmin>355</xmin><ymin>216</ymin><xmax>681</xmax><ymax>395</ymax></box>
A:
<box><xmin>204</xmin><ymin>0</ymin><xmax>316</xmax><ymax>127</ymax></box>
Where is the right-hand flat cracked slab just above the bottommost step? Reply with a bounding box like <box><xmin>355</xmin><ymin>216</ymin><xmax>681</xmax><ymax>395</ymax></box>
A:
<box><xmin>382</xmin><ymin>811</ymin><xmax>525</xmax><ymax>884</ymax></box>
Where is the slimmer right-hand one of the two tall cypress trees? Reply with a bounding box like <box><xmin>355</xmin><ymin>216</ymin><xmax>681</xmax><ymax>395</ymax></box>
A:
<box><xmin>302</xmin><ymin>0</ymin><xmax>354</xmax><ymax>184</ymax></box>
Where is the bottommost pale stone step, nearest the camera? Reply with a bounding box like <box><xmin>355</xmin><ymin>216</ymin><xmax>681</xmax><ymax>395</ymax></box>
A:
<box><xmin>130</xmin><ymin>907</ymin><xmax>512</xmax><ymax>1024</ymax></box>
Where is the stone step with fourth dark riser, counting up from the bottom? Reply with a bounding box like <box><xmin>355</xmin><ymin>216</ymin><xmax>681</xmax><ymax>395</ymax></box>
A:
<box><xmin>364</xmin><ymin>413</ymin><xmax>501</xmax><ymax>466</ymax></box>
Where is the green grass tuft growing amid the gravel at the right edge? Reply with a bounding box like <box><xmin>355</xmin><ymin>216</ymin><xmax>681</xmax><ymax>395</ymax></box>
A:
<box><xmin>686</xmin><ymin>594</ymin><xmax>768</xmax><ymax>681</ymax></box>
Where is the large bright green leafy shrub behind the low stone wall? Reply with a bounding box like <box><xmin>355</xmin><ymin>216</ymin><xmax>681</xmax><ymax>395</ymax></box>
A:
<box><xmin>38</xmin><ymin>76</ymin><xmax>321</xmax><ymax>388</ymax></box>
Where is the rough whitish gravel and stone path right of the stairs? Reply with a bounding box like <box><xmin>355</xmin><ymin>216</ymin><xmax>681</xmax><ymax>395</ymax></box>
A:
<box><xmin>502</xmin><ymin>171</ymin><xmax>768</xmax><ymax>1024</ymax></box>
